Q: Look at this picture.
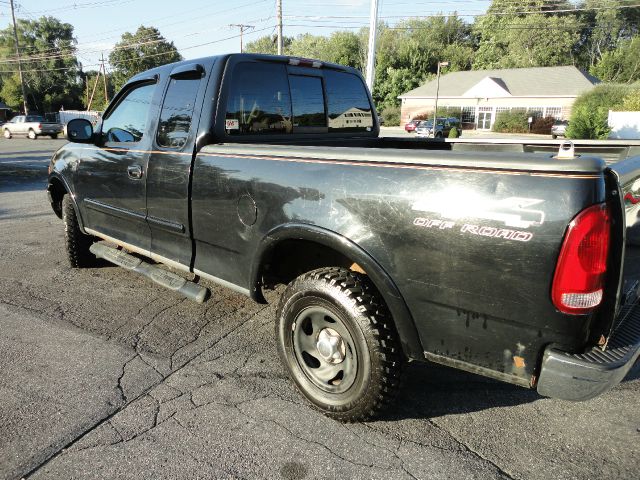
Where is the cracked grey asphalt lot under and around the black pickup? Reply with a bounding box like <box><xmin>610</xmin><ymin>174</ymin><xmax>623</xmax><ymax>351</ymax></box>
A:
<box><xmin>0</xmin><ymin>139</ymin><xmax>640</xmax><ymax>480</ymax></box>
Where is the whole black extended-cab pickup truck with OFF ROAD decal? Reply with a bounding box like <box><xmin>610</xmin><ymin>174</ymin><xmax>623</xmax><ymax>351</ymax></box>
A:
<box><xmin>48</xmin><ymin>55</ymin><xmax>640</xmax><ymax>421</ymax></box>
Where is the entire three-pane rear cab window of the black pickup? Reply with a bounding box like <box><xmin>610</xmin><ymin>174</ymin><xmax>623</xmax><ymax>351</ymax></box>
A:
<box><xmin>223</xmin><ymin>61</ymin><xmax>375</xmax><ymax>136</ymax></box>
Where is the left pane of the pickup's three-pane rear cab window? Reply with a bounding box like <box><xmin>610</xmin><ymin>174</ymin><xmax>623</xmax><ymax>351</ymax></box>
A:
<box><xmin>225</xmin><ymin>62</ymin><xmax>292</xmax><ymax>135</ymax></box>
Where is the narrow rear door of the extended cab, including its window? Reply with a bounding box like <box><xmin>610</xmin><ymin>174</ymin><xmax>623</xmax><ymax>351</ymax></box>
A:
<box><xmin>147</xmin><ymin>63</ymin><xmax>207</xmax><ymax>266</ymax></box>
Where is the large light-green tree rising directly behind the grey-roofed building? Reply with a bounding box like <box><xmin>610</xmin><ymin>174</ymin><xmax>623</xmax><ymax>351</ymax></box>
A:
<box><xmin>473</xmin><ymin>0</ymin><xmax>580</xmax><ymax>69</ymax></box>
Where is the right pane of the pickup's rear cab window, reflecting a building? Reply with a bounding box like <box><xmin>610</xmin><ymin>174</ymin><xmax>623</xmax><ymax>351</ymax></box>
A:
<box><xmin>324</xmin><ymin>70</ymin><xmax>373</xmax><ymax>132</ymax></box>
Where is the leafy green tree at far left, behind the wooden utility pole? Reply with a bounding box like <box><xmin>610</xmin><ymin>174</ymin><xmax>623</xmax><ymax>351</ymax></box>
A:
<box><xmin>0</xmin><ymin>17</ymin><xmax>82</xmax><ymax>113</ymax></box>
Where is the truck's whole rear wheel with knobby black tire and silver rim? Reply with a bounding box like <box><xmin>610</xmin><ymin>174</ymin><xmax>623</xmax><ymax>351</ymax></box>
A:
<box><xmin>276</xmin><ymin>267</ymin><xmax>403</xmax><ymax>422</ymax></box>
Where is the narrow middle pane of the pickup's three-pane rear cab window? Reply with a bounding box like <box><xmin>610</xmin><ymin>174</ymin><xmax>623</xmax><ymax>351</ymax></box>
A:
<box><xmin>289</xmin><ymin>75</ymin><xmax>327</xmax><ymax>131</ymax></box>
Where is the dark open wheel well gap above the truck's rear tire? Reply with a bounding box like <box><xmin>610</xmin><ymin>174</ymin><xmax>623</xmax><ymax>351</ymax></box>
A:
<box><xmin>261</xmin><ymin>240</ymin><xmax>362</xmax><ymax>288</ymax></box>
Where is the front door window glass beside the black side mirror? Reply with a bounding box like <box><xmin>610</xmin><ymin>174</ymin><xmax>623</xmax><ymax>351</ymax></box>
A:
<box><xmin>102</xmin><ymin>84</ymin><xmax>155</xmax><ymax>142</ymax></box>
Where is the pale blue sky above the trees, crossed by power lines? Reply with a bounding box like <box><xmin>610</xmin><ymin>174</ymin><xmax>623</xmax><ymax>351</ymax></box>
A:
<box><xmin>0</xmin><ymin>0</ymin><xmax>490</xmax><ymax>70</ymax></box>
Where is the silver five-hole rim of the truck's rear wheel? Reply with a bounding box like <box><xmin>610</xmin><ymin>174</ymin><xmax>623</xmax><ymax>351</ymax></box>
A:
<box><xmin>291</xmin><ymin>306</ymin><xmax>358</xmax><ymax>393</ymax></box>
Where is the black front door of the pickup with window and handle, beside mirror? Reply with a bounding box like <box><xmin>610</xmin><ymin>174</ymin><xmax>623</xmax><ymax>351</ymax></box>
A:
<box><xmin>74</xmin><ymin>79</ymin><xmax>157</xmax><ymax>250</ymax></box>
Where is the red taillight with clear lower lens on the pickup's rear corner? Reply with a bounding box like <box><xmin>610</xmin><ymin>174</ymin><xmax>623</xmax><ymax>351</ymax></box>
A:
<box><xmin>551</xmin><ymin>204</ymin><xmax>611</xmax><ymax>314</ymax></box>
